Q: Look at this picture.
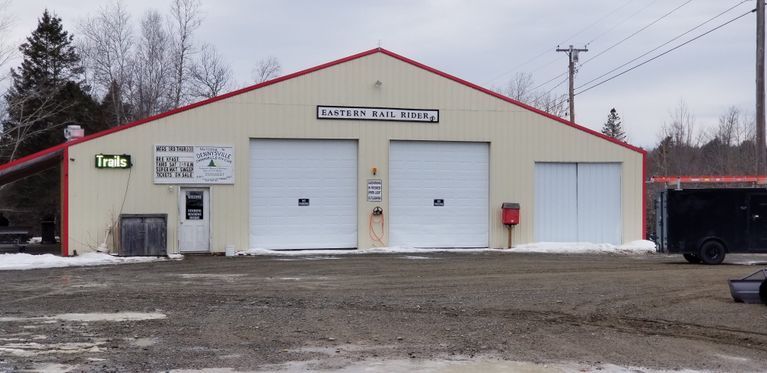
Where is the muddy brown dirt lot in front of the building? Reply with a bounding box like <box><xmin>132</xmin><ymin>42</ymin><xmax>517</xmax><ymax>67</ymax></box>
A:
<box><xmin>0</xmin><ymin>253</ymin><xmax>767</xmax><ymax>371</ymax></box>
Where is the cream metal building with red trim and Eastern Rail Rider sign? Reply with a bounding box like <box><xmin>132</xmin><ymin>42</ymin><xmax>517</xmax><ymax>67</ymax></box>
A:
<box><xmin>0</xmin><ymin>48</ymin><xmax>645</xmax><ymax>255</ymax></box>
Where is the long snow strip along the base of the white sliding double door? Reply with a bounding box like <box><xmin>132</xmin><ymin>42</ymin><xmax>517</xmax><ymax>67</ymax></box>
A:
<box><xmin>509</xmin><ymin>240</ymin><xmax>655</xmax><ymax>254</ymax></box>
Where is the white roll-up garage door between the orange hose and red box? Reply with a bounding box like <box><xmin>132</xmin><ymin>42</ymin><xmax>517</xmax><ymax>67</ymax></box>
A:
<box><xmin>389</xmin><ymin>141</ymin><xmax>489</xmax><ymax>247</ymax></box>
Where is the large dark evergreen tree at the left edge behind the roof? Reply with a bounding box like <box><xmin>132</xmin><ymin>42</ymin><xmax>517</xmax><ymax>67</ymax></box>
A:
<box><xmin>0</xmin><ymin>10</ymin><xmax>106</xmax><ymax>230</ymax></box>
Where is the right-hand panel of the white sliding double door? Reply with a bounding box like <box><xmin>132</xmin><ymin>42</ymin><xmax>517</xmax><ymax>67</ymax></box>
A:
<box><xmin>578</xmin><ymin>163</ymin><xmax>622</xmax><ymax>245</ymax></box>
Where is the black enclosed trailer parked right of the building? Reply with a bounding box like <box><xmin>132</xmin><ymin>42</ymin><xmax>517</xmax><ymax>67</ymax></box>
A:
<box><xmin>656</xmin><ymin>188</ymin><xmax>767</xmax><ymax>264</ymax></box>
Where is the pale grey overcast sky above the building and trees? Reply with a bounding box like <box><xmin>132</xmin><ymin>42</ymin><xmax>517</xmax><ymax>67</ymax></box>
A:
<box><xmin>1</xmin><ymin>0</ymin><xmax>756</xmax><ymax>147</ymax></box>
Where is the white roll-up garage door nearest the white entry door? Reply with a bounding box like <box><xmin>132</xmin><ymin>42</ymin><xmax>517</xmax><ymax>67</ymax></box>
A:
<box><xmin>250</xmin><ymin>139</ymin><xmax>357</xmax><ymax>249</ymax></box>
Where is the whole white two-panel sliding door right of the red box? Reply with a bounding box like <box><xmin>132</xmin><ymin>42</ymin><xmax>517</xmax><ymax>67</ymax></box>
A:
<box><xmin>535</xmin><ymin>163</ymin><xmax>622</xmax><ymax>244</ymax></box>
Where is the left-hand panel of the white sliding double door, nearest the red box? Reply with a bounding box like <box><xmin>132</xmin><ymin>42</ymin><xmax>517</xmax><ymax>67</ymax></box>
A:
<box><xmin>535</xmin><ymin>163</ymin><xmax>578</xmax><ymax>242</ymax></box>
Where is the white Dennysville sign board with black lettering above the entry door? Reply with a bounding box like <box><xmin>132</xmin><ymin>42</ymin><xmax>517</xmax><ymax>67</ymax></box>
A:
<box><xmin>154</xmin><ymin>145</ymin><xmax>234</xmax><ymax>184</ymax></box>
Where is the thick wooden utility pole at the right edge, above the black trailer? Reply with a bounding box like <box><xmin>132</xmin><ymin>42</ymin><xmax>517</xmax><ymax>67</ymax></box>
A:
<box><xmin>756</xmin><ymin>0</ymin><xmax>767</xmax><ymax>176</ymax></box>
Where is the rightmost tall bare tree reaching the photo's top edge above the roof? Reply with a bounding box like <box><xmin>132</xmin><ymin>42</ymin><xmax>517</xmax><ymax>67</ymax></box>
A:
<box><xmin>169</xmin><ymin>0</ymin><xmax>202</xmax><ymax>107</ymax></box>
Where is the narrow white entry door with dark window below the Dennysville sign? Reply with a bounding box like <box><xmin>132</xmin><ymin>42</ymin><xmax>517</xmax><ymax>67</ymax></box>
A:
<box><xmin>178</xmin><ymin>187</ymin><xmax>210</xmax><ymax>252</ymax></box>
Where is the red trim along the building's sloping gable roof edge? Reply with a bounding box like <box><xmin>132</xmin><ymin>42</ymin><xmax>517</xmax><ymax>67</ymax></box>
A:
<box><xmin>0</xmin><ymin>48</ymin><xmax>647</xmax><ymax>170</ymax></box>
